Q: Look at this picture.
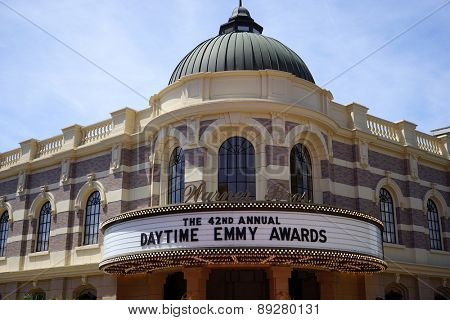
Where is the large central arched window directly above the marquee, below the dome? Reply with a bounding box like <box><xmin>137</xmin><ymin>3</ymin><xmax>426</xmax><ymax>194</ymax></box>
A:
<box><xmin>219</xmin><ymin>137</ymin><xmax>256</xmax><ymax>200</ymax></box>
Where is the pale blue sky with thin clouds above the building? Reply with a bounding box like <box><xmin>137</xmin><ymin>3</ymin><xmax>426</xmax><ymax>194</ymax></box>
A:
<box><xmin>0</xmin><ymin>0</ymin><xmax>450</xmax><ymax>152</ymax></box>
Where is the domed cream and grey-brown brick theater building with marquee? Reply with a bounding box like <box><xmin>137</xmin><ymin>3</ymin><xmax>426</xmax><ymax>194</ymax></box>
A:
<box><xmin>0</xmin><ymin>5</ymin><xmax>450</xmax><ymax>300</ymax></box>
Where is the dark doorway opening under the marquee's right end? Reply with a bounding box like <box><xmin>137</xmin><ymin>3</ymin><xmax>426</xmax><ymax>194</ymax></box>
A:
<box><xmin>289</xmin><ymin>269</ymin><xmax>320</xmax><ymax>300</ymax></box>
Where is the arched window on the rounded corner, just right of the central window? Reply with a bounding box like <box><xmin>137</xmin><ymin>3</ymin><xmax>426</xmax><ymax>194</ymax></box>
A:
<box><xmin>290</xmin><ymin>144</ymin><xmax>313</xmax><ymax>202</ymax></box>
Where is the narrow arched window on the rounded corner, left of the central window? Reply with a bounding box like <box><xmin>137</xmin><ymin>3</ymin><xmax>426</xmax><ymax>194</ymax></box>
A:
<box><xmin>167</xmin><ymin>147</ymin><xmax>184</xmax><ymax>204</ymax></box>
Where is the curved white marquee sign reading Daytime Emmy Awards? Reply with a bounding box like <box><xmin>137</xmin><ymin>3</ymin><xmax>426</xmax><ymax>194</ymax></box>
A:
<box><xmin>101</xmin><ymin>203</ymin><xmax>384</xmax><ymax>272</ymax></box>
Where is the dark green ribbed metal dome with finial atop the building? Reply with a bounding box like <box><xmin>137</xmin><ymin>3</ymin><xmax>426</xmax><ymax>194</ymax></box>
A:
<box><xmin>169</xmin><ymin>2</ymin><xmax>315</xmax><ymax>85</ymax></box>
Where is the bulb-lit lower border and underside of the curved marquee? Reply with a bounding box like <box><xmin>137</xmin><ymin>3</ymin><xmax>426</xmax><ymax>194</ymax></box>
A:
<box><xmin>100</xmin><ymin>248</ymin><xmax>387</xmax><ymax>275</ymax></box>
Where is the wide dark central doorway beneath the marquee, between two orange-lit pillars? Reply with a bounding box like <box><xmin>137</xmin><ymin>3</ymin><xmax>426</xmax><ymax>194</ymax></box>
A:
<box><xmin>206</xmin><ymin>269</ymin><xmax>269</xmax><ymax>300</ymax></box>
